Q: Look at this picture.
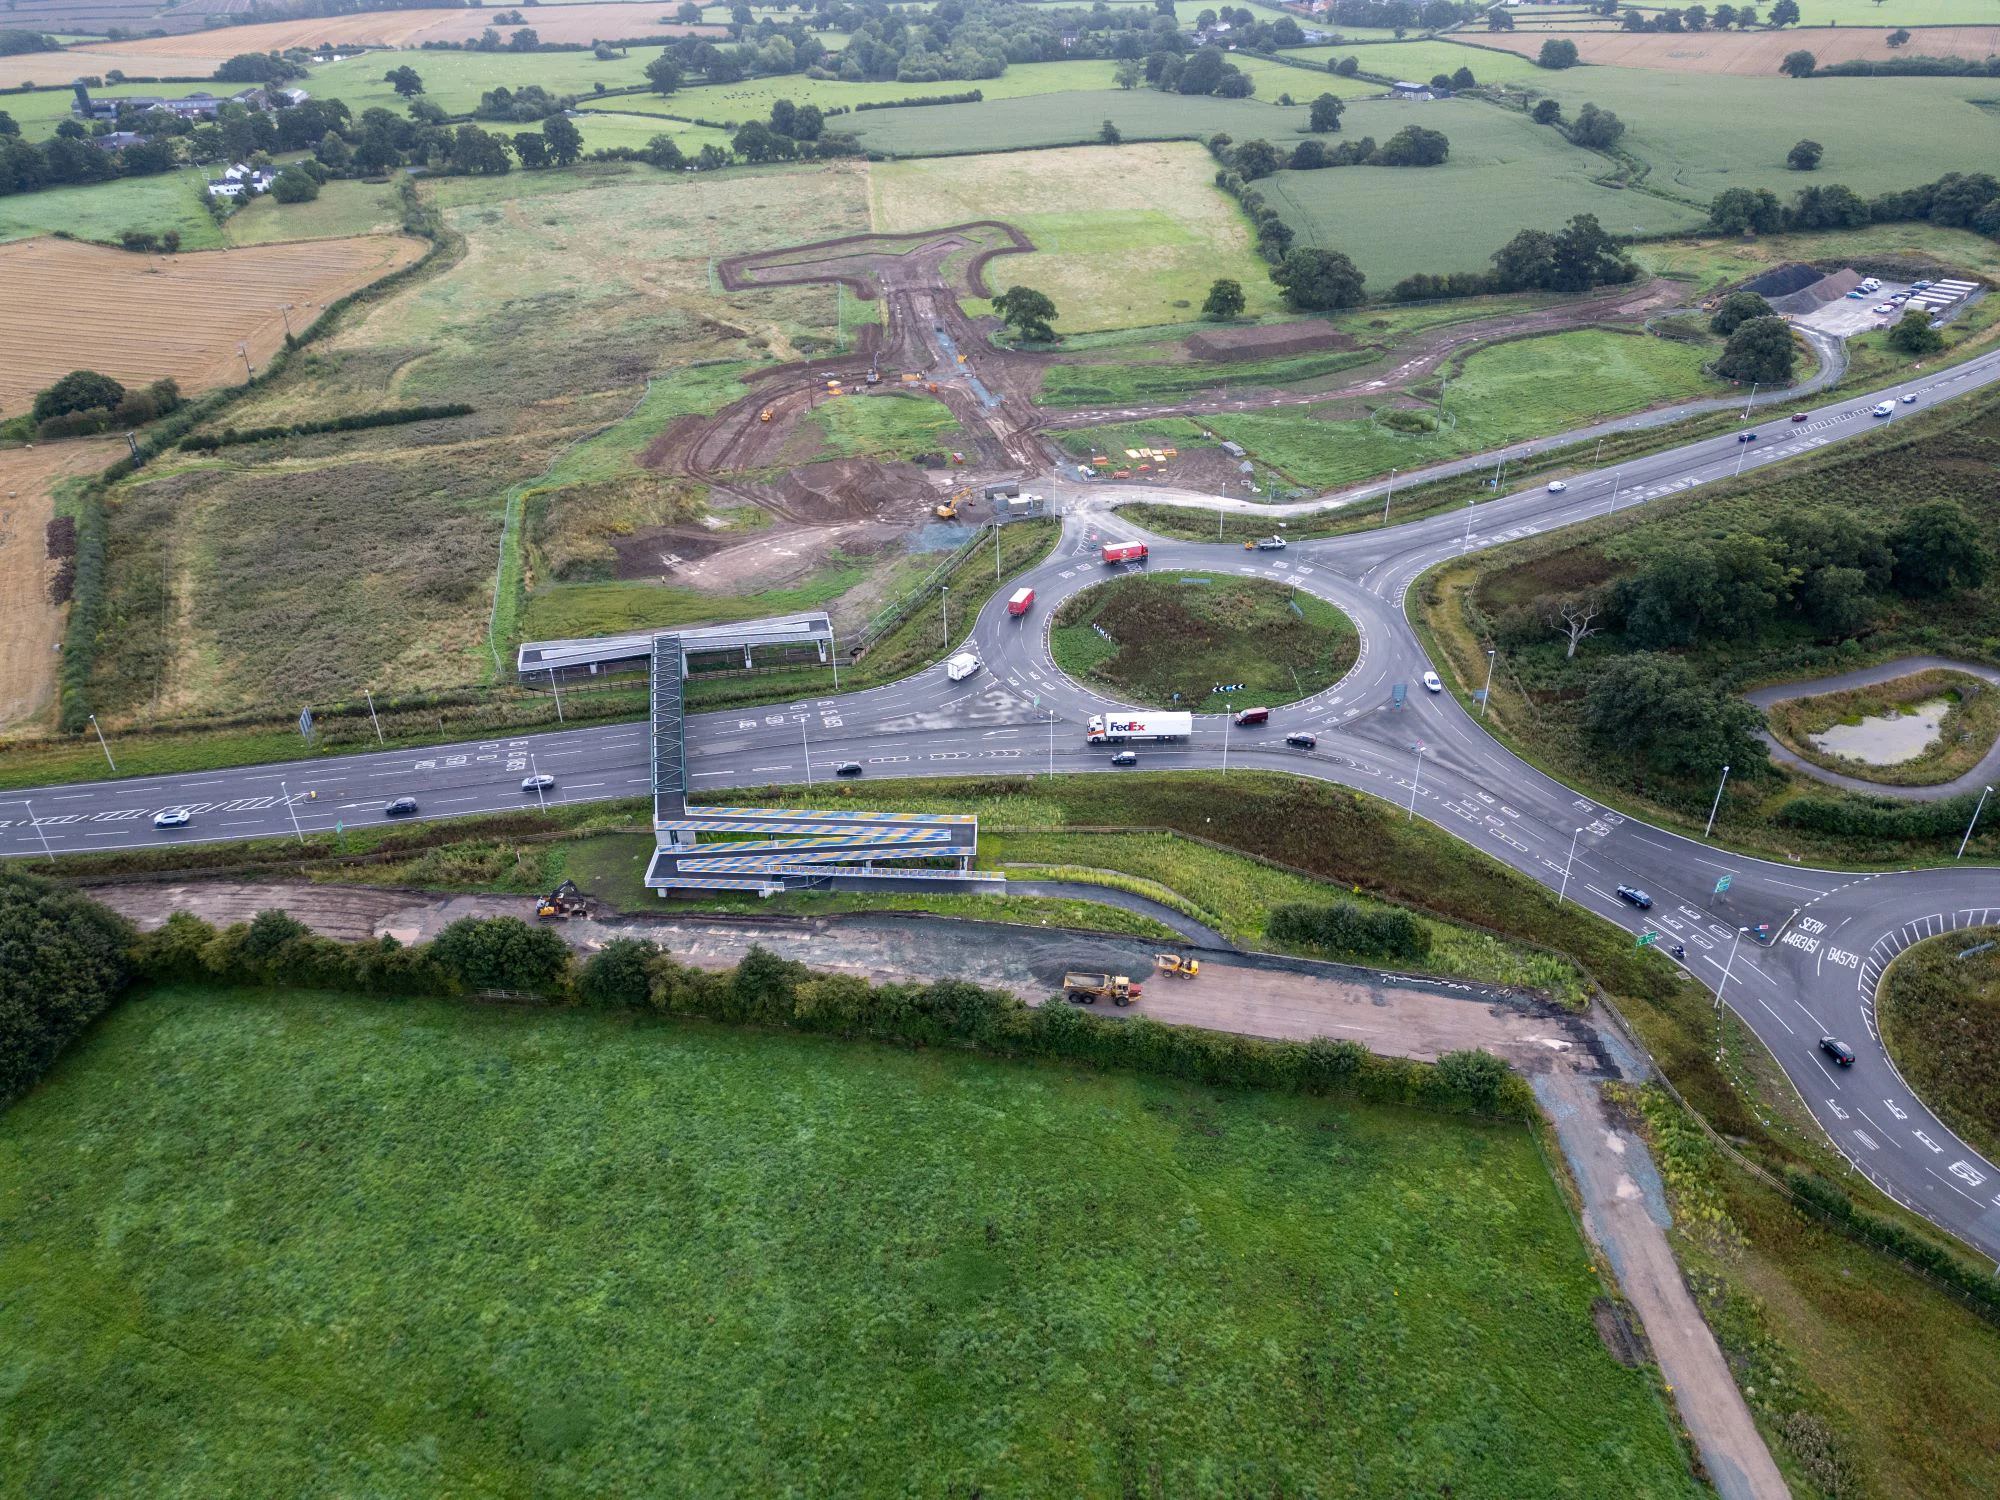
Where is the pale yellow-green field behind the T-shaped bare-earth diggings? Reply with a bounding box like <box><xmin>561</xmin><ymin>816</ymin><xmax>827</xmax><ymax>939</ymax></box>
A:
<box><xmin>868</xmin><ymin>142</ymin><xmax>1278</xmax><ymax>334</ymax></box>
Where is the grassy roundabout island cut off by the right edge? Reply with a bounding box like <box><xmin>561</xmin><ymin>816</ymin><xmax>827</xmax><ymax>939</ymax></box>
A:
<box><xmin>1876</xmin><ymin>928</ymin><xmax>2000</xmax><ymax>1160</ymax></box>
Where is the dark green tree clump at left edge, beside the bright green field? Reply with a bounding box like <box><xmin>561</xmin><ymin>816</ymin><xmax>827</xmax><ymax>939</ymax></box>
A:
<box><xmin>0</xmin><ymin>866</ymin><xmax>132</xmax><ymax>1100</ymax></box>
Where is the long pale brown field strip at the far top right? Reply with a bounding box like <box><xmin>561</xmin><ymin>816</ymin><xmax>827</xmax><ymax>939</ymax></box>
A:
<box><xmin>1470</xmin><ymin>26</ymin><xmax>2000</xmax><ymax>78</ymax></box>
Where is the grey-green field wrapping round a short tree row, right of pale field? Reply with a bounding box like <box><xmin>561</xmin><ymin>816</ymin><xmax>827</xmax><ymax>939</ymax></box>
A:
<box><xmin>1258</xmin><ymin>100</ymin><xmax>1704</xmax><ymax>292</ymax></box>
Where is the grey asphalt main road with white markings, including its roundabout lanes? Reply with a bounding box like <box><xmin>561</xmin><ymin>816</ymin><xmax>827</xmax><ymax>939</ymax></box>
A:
<box><xmin>11</xmin><ymin>352</ymin><xmax>2000</xmax><ymax>1258</ymax></box>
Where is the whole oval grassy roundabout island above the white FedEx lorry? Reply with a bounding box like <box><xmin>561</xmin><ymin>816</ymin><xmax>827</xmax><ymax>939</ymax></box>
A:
<box><xmin>1050</xmin><ymin>568</ymin><xmax>1360</xmax><ymax>714</ymax></box>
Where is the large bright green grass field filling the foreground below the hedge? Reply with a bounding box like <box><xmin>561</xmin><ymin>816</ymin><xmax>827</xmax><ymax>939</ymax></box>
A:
<box><xmin>0</xmin><ymin>990</ymin><xmax>1696</xmax><ymax>1496</ymax></box>
